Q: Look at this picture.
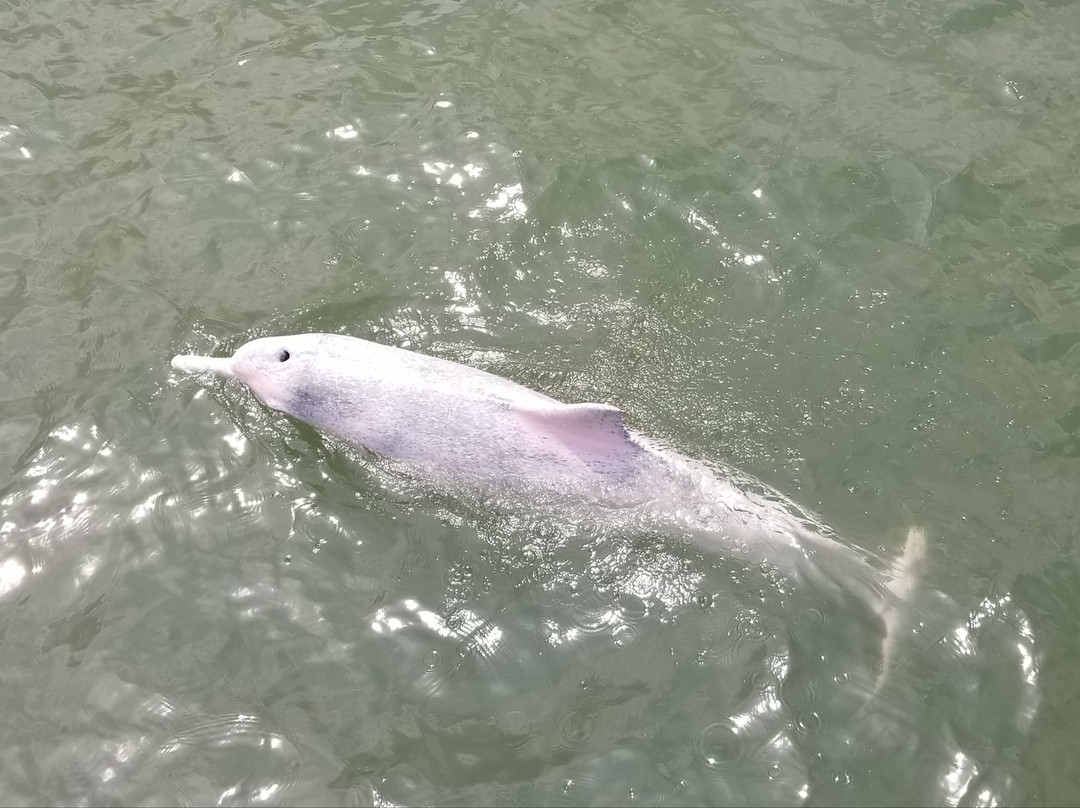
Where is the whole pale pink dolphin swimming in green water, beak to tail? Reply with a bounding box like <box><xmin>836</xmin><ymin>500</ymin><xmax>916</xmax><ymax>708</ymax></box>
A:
<box><xmin>172</xmin><ymin>334</ymin><xmax>926</xmax><ymax>695</ymax></box>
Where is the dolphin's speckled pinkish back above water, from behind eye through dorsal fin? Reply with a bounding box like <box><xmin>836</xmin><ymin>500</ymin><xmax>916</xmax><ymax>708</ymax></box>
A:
<box><xmin>260</xmin><ymin>335</ymin><xmax>644</xmax><ymax>481</ymax></box>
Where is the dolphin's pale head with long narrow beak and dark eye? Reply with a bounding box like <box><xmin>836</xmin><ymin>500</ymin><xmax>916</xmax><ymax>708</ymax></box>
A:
<box><xmin>173</xmin><ymin>334</ymin><xmax>322</xmax><ymax>410</ymax></box>
